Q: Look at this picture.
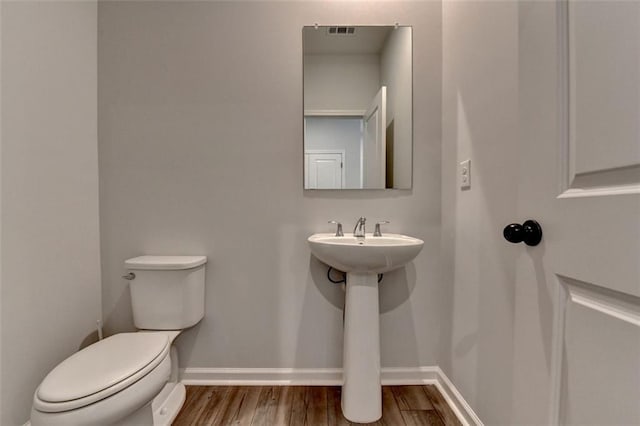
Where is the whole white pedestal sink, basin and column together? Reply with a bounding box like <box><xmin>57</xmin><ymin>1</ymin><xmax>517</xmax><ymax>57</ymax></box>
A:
<box><xmin>307</xmin><ymin>234</ymin><xmax>424</xmax><ymax>423</ymax></box>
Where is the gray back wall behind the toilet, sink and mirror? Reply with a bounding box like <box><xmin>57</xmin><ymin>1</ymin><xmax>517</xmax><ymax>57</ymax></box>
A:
<box><xmin>98</xmin><ymin>1</ymin><xmax>450</xmax><ymax>368</ymax></box>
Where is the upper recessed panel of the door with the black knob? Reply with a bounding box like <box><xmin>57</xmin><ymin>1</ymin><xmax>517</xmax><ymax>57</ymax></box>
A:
<box><xmin>563</xmin><ymin>1</ymin><xmax>640</xmax><ymax>195</ymax></box>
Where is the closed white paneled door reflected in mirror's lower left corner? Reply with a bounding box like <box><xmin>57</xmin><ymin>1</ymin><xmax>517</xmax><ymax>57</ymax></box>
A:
<box><xmin>304</xmin><ymin>152</ymin><xmax>344</xmax><ymax>189</ymax></box>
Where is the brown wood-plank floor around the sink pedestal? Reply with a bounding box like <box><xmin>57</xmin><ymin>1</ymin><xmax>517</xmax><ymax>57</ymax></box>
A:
<box><xmin>173</xmin><ymin>385</ymin><xmax>460</xmax><ymax>426</ymax></box>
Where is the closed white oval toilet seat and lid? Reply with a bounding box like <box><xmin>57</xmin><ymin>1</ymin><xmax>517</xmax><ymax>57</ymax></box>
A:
<box><xmin>33</xmin><ymin>333</ymin><xmax>171</xmax><ymax>413</ymax></box>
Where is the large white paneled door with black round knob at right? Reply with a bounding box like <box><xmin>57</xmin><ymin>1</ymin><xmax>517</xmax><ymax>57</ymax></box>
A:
<box><xmin>513</xmin><ymin>1</ymin><xmax>640</xmax><ymax>425</ymax></box>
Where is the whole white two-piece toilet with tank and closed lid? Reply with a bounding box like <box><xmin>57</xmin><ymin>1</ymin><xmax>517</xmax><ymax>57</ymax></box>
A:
<box><xmin>31</xmin><ymin>256</ymin><xmax>207</xmax><ymax>426</ymax></box>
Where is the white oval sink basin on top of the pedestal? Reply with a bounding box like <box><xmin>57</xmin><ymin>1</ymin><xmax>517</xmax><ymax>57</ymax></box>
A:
<box><xmin>307</xmin><ymin>234</ymin><xmax>424</xmax><ymax>274</ymax></box>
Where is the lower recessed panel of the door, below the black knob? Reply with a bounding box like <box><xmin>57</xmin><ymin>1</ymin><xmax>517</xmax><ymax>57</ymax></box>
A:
<box><xmin>558</xmin><ymin>277</ymin><xmax>640</xmax><ymax>425</ymax></box>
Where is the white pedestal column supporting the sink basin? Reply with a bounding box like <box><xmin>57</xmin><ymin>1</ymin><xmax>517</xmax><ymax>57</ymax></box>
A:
<box><xmin>342</xmin><ymin>272</ymin><xmax>382</xmax><ymax>423</ymax></box>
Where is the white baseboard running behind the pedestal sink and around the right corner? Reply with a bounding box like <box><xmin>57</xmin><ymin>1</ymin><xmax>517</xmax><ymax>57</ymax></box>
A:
<box><xmin>180</xmin><ymin>366</ymin><xmax>482</xmax><ymax>426</ymax></box>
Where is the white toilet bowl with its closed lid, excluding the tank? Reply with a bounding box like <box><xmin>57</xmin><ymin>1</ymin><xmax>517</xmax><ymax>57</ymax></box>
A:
<box><xmin>31</xmin><ymin>332</ymin><xmax>177</xmax><ymax>425</ymax></box>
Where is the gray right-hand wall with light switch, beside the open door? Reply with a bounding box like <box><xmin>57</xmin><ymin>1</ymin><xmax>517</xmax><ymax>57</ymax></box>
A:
<box><xmin>441</xmin><ymin>1</ymin><xmax>520</xmax><ymax>424</ymax></box>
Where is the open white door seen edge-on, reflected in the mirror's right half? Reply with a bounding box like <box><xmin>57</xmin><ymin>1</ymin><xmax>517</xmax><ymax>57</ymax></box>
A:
<box><xmin>362</xmin><ymin>86</ymin><xmax>387</xmax><ymax>188</ymax></box>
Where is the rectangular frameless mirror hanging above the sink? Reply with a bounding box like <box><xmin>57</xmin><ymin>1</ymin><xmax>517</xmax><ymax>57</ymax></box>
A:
<box><xmin>302</xmin><ymin>26</ymin><xmax>413</xmax><ymax>189</ymax></box>
